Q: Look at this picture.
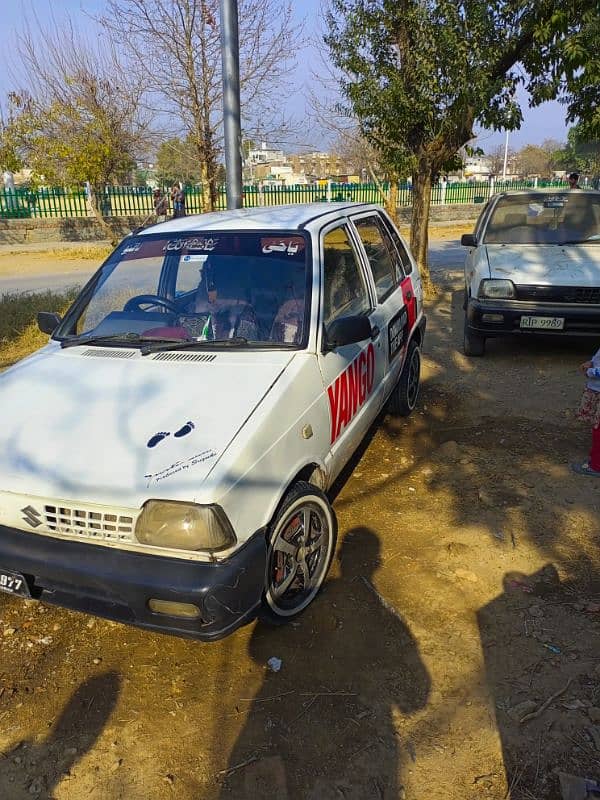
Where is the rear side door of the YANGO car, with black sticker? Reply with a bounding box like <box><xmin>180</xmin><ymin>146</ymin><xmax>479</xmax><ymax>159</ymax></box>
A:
<box><xmin>352</xmin><ymin>211</ymin><xmax>416</xmax><ymax>403</ymax></box>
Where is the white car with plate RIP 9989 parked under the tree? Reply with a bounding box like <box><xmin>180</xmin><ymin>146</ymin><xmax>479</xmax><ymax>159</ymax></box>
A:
<box><xmin>461</xmin><ymin>189</ymin><xmax>600</xmax><ymax>356</ymax></box>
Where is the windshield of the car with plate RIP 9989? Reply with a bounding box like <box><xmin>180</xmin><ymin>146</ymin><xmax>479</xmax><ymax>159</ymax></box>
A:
<box><xmin>483</xmin><ymin>192</ymin><xmax>600</xmax><ymax>244</ymax></box>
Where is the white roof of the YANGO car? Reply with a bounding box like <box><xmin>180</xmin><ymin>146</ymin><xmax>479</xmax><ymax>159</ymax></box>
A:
<box><xmin>136</xmin><ymin>202</ymin><xmax>379</xmax><ymax>235</ymax></box>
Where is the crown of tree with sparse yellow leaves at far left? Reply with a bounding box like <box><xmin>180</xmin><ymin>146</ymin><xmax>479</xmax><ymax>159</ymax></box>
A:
<box><xmin>12</xmin><ymin>18</ymin><xmax>148</xmax><ymax>194</ymax></box>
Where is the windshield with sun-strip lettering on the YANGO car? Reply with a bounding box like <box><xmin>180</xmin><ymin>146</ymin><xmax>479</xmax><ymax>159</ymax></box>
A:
<box><xmin>62</xmin><ymin>231</ymin><xmax>311</xmax><ymax>347</ymax></box>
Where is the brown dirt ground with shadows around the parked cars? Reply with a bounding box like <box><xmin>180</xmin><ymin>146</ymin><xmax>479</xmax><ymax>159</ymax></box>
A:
<box><xmin>0</xmin><ymin>247</ymin><xmax>600</xmax><ymax>800</ymax></box>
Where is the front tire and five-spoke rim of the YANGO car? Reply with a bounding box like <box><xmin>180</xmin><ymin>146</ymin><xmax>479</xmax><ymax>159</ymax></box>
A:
<box><xmin>261</xmin><ymin>481</ymin><xmax>337</xmax><ymax>624</ymax></box>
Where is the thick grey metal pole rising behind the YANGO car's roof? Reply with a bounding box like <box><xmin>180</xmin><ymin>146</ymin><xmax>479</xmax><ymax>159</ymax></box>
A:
<box><xmin>220</xmin><ymin>0</ymin><xmax>243</xmax><ymax>208</ymax></box>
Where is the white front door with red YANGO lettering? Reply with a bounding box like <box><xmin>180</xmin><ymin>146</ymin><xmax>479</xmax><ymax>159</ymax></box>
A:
<box><xmin>318</xmin><ymin>222</ymin><xmax>385</xmax><ymax>475</ymax></box>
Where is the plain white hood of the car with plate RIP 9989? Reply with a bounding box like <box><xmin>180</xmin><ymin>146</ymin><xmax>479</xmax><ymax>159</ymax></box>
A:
<box><xmin>486</xmin><ymin>242</ymin><xmax>600</xmax><ymax>286</ymax></box>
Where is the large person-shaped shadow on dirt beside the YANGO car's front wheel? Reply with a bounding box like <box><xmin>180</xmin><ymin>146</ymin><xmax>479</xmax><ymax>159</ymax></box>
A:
<box><xmin>220</xmin><ymin>527</ymin><xmax>430</xmax><ymax>800</ymax></box>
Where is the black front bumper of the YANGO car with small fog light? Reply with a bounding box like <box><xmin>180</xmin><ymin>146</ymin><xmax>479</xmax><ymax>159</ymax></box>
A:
<box><xmin>0</xmin><ymin>525</ymin><xmax>267</xmax><ymax>641</ymax></box>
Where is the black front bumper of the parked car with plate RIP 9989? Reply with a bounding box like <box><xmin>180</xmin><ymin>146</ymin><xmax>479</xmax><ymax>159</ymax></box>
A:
<box><xmin>466</xmin><ymin>298</ymin><xmax>600</xmax><ymax>337</ymax></box>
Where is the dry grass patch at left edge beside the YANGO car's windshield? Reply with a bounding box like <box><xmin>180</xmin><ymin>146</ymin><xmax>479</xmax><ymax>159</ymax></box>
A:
<box><xmin>0</xmin><ymin>289</ymin><xmax>78</xmax><ymax>369</ymax></box>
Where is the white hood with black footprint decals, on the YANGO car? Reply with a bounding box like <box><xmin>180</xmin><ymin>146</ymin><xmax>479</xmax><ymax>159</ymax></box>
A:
<box><xmin>0</xmin><ymin>343</ymin><xmax>294</xmax><ymax>507</ymax></box>
